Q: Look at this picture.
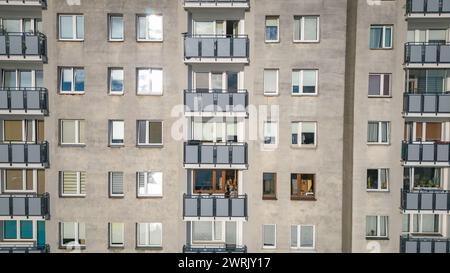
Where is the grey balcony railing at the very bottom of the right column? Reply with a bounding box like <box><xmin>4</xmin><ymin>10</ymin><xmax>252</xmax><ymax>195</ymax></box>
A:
<box><xmin>400</xmin><ymin>236</ymin><xmax>450</xmax><ymax>253</ymax></box>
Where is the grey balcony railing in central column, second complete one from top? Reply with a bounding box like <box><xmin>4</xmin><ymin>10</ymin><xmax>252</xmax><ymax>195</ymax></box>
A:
<box><xmin>184</xmin><ymin>90</ymin><xmax>248</xmax><ymax>117</ymax></box>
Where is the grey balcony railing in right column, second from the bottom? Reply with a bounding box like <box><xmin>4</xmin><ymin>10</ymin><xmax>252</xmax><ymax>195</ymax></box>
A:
<box><xmin>401</xmin><ymin>190</ymin><xmax>450</xmax><ymax>213</ymax></box>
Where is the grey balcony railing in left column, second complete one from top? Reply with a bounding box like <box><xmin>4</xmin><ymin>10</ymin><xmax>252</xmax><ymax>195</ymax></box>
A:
<box><xmin>0</xmin><ymin>87</ymin><xmax>48</xmax><ymax>115</ymax></box>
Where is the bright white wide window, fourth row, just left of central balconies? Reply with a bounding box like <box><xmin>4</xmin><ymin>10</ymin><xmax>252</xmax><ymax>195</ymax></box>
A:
<box><xmin>137</xmin><ymin>172</ymin><xmax>163</xmax><ymax>197</ymax></box>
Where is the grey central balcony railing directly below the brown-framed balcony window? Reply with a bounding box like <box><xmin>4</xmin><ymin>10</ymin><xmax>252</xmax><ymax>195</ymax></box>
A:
<box><xmin>183</xmin><ymin>194</ymin><xmax>248</xmax><ymax>218</ymax></box>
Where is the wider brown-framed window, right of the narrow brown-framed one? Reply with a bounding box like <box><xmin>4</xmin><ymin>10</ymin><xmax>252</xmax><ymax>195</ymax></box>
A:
<box><xmin>291</xmin><ymin>174</ymin><xmax>316</xmax><ymax>200</ymax></box>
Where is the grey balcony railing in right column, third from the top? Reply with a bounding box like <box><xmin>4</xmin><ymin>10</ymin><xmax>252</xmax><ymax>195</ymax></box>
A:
<box><xmin>403</xmin><ymin>93</ymin><xmax>450</xmax><ymax>117</ymax></box>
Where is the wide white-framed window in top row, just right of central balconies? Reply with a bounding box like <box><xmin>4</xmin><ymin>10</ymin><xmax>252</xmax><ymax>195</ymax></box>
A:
<box><xmin>294</xmin><ymin>16</ymin><xmax>319</xmax><ymax>42</ymax></box>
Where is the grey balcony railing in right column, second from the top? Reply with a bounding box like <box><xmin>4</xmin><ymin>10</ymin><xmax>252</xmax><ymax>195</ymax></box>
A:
<box><xmin>405</xmin><ymin>43</ymin><xmax>450</xmax><ymax>65</ymax></box>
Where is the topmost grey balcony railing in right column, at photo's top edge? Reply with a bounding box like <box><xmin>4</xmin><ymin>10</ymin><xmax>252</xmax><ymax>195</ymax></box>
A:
<box><xmin>406</xmin><ymin>0</ymin><xmax>450</xmax><ymax>15</ymax></box>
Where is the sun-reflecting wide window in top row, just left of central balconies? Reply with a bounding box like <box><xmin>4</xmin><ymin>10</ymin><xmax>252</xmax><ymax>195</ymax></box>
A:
<box><xmin>137</xmin><ymin>14</ymin><xmax>163</xmax><ymax>41</ymax></box>
